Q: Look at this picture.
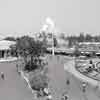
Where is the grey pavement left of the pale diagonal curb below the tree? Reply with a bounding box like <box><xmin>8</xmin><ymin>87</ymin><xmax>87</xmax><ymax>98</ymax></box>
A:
<box><xmin>0</xmin><ymin>62</ymin><xmax>33</xmax><ymax>100</ymax></box>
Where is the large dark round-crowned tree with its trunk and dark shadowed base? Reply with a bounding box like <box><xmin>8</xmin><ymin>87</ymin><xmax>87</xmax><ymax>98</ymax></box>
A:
<box><xmin>11</xmin><ymin>36</ymin><xmax>46</xmax><ymax>71</ymax></box>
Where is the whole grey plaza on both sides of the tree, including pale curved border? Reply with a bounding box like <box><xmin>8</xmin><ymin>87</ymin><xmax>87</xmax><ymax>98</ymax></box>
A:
<box><xmin>0</xmin><ymin>55</ymin><xmax>100</xmax><ymax>100</ymax></box>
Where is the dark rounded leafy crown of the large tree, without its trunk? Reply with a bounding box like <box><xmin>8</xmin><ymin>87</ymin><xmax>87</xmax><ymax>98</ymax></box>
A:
<box><xmin>16</xmin><ymin>36</ymin><xmax>46</xmax><ymax>57</ymax></box>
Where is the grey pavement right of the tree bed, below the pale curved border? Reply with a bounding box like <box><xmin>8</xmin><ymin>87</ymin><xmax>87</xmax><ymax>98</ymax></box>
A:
<box><xmin>48</xmin><ymin>56</ymin><xmax>100</xmax><ymax>100</ymax></box>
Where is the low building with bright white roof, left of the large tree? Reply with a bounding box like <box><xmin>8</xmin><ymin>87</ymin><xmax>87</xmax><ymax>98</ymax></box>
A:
<box><xmin>0</xmin><ymin>40</ymin><xmax>16</xmax><ymax>58</ymax></box>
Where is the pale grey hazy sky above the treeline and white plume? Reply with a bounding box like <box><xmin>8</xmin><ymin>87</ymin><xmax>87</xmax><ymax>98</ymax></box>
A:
<box><xmin>0</xmin><ymin>0</ymin><xmax>100</xmax><ymax>35</ymax></box>
